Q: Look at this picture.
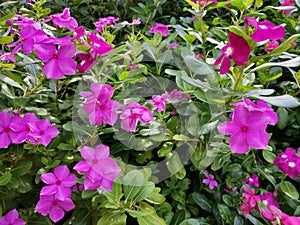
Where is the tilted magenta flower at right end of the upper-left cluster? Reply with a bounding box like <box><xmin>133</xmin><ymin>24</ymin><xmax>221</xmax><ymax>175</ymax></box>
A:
<box><xmin>88</xmin><ymin>31</ymin><xmax>113</xmax><ymax>57</ymax></box>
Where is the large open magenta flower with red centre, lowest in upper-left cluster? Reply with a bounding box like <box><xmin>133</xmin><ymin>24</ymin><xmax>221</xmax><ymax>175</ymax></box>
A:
<box><xmin>35</xmin><ymin>41</ymin><xmax>76</xmax><ymax>79</ymax></box>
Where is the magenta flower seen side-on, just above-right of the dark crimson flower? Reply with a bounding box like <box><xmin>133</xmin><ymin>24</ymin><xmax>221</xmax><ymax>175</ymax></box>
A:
<box><xmin>245</xmin><ymin>16</ymin><xmax>285</xmax><ymax>42</ymax></box>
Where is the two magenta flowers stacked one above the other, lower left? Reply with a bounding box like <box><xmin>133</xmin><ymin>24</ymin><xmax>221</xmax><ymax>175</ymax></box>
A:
<box><xmin>35</xmin><ymin>165</ymin><xmax>77</xmax><ymax>222</ymax></box>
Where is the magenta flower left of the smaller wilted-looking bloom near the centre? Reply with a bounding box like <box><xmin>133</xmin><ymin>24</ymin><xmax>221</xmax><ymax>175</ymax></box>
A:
<box><xmin>79</xmin><ymin>83</ymin><xmax>120</xmax><ymax>125</ymax></box>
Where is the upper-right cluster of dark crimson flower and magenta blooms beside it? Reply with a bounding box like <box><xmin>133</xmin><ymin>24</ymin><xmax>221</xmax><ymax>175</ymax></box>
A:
<box><xmin>214</xmin><ymin>16</ymin><xmax>285</xmax><ymax>74</ymax></box>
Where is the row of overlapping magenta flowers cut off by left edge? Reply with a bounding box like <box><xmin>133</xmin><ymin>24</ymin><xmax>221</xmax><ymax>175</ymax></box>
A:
<box><xmin>0</xmin><ymin>110</ymin><xmax>59</xmax><ymax>148</ymax></box>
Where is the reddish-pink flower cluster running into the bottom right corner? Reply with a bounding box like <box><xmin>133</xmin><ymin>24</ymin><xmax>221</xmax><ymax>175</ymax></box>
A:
<box><xmin>239</xmin><ymin>185</ymin><xmax>300</xmax><ymax>225</ymax></box>
